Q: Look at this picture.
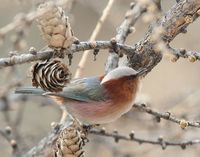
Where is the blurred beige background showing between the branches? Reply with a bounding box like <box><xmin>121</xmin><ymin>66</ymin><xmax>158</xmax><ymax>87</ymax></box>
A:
<box><xmin>0</xmin><ymin>0</ymin><xmax>200</xmax><ymax>157</ymax></box>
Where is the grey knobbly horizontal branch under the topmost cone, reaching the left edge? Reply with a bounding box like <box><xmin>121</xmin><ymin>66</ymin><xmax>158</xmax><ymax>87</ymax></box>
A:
<box><xmin>0</xmin><ymin>41</ymin><xmax>134</xmax><ymax>69</ymax></box>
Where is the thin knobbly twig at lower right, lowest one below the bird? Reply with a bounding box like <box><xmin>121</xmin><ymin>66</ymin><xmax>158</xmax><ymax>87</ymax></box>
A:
<box><xmin>90</xmin><ymin>129</ymin><xmax>200</xmax><ymax>149</ymax></box>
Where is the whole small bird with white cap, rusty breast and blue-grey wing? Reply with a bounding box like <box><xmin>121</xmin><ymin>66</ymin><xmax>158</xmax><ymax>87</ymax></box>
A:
<box><xmin>15</xmin><ymin>67</ymin><xmax>146</xmax><ymax>124</ymax></box>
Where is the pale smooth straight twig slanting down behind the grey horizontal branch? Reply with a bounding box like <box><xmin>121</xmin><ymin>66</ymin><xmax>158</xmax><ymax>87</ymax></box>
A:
<box><xmin>74</xmin><ymin>0</ymin><xmax>115</xmax><ymax>78</ymax></box>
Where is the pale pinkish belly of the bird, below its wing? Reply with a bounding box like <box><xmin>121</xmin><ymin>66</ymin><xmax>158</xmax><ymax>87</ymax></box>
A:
<box><xmin>66</xmin><ymin>101</ymin><xmax>133</xmax><ymax>124</ymax></box>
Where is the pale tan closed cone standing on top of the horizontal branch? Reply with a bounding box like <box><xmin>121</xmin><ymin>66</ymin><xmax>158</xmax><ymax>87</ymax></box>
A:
<box><xmin>37</xmin><ymin>2</ymin><xmax>77</xmax><ymax>48</ymax></box>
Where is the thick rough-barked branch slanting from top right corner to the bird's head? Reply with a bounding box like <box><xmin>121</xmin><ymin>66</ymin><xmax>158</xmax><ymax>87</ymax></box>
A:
<box><xmin>128</xmin><ymin>0</ymin><xmax>200</xmax><ymax>71</ymax></box>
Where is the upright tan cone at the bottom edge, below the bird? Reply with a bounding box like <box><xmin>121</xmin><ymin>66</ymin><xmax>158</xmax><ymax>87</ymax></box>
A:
<box><xmin>55</xmin><ymin>127</ymin><xmax>84</xmax><ymax>157</ymax></box>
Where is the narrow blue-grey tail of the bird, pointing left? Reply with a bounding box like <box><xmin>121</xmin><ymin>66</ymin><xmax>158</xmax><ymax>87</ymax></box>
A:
<box><xmin>15</xmin><ymin>87</ymin><xmax>45</xmax><ymax>95</ymax></box>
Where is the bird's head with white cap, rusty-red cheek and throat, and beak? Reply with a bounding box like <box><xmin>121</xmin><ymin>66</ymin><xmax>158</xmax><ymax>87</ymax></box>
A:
<box><xmin>101</xmin><ymin>67</ymin><xmax>144</xmax><ymax>106</ymax></box>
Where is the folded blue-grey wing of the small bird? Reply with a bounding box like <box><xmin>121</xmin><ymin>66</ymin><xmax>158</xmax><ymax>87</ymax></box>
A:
<box><xmin>44</xmin><ymin>77</ymin><xmax>108</xmax><ymax>102</ymax></box>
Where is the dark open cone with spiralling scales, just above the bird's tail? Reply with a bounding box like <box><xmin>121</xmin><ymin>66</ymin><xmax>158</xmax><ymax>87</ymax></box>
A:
<box><xmin>32</xmin><ymin>60</ymin><xmax>71</xmax><ymax>92</ymax></box>
